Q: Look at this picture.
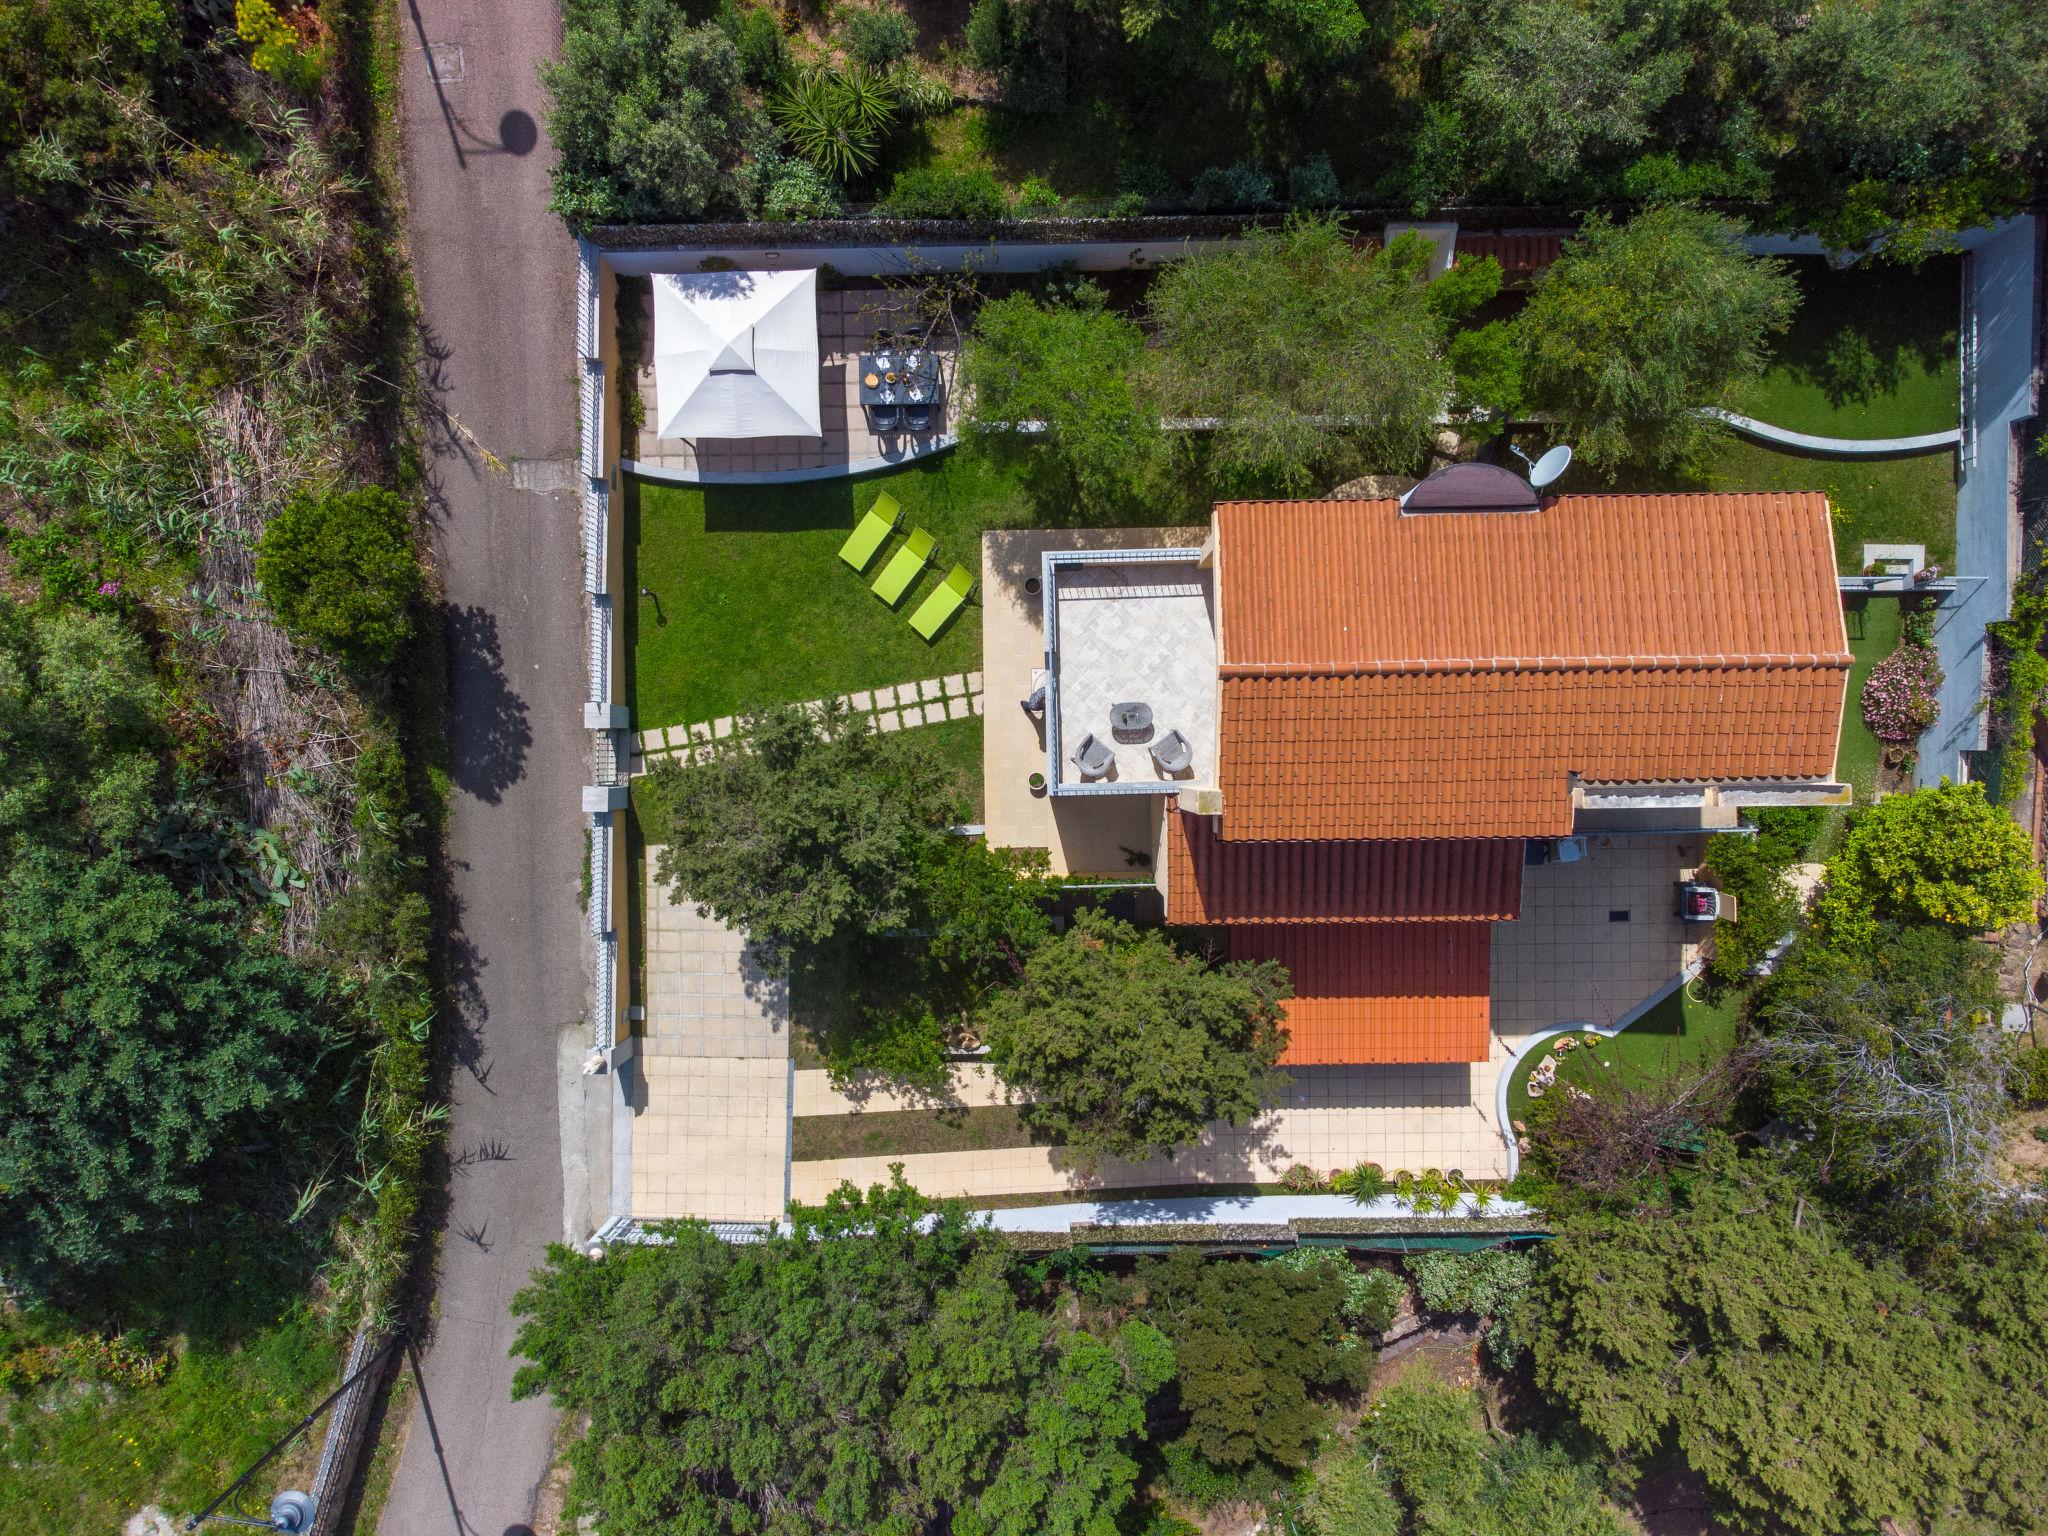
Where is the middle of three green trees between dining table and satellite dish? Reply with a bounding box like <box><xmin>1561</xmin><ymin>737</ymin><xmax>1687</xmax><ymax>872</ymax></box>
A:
<box><xmin>1151</xmin><ymin>217</ymin><xmax>1452</xmax><ymax>492</ymax></box>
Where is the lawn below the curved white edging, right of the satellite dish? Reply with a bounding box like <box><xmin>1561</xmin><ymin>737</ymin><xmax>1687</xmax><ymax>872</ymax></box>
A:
<box><xmin>1704</xmin><ymin>438</ymin><xmax>1956</xmax><ymax>575</ymax></box>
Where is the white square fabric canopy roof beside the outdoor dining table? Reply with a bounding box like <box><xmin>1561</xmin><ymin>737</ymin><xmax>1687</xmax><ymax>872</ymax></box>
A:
<box><xmin>653</xmin><ymin>270</ymin><xmax>825</xmax><ymax>438</ymax></box>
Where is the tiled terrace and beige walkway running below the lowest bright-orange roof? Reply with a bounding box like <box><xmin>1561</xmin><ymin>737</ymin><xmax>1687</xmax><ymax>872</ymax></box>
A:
<box><xmin>791</xmin><ymin>836</ymin><xmax>1700</xmax><ymax>1200</ymax></box>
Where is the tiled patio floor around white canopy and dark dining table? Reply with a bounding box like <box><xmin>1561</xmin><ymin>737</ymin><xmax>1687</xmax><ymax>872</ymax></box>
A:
<box><xmin>631</xmin><ymin>289</ymin><xmax>954</xmax><ymax>473</ymax></box>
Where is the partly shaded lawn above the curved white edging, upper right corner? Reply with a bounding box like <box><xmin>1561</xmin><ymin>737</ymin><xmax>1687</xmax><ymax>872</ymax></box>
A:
<box><xmin>1743</xmin><ymin>256</ymin><xmax>1962</xmax><ymax>438</ymax></box>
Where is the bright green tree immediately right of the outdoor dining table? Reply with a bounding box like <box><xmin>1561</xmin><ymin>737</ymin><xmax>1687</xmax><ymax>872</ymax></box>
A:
<box><xmin>958</xmin><ymin>283</ymin><xmax>1163</xmax><ymax>514</ymax></box>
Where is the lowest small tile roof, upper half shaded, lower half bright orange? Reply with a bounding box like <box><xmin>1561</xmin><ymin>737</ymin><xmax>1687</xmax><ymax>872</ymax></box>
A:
<box><xmin>1229</xmin><ymin>924</ymin><xmax>1493</xmax><ymax>1067</ymax></box>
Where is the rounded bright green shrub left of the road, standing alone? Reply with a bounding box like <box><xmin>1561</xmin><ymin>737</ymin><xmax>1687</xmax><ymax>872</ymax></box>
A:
<box><xmin>256</xmin><ymin>485</ymin><xmax>420</xmax><ymax>666</ymax></box>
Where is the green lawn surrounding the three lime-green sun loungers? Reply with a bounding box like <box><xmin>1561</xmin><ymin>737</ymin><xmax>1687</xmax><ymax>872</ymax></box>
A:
<box><xmin>623</xmin><ymin>453</ymin><xmax>1032</xmax><ymax>729</ymax></box>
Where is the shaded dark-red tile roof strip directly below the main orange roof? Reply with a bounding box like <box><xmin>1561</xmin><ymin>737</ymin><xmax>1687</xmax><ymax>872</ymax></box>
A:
<box><xmin>1165</xmin><ymin>811</ymin><xmax>1522</xmax><ymax>926</ymax></box>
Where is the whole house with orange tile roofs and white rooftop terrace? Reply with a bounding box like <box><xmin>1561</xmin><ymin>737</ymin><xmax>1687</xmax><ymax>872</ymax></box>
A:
<box><xmin>1007</xmin><ymin>479</ymin><xmax>1851</xmax><ymax>1067</ymax></box>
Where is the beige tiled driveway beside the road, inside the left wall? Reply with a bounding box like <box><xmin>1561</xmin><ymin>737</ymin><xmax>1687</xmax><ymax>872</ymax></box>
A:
<box><xmin>633</xmin><ymin>848</ymin><xmax>791</xmax><ymax>1221</ymax></box>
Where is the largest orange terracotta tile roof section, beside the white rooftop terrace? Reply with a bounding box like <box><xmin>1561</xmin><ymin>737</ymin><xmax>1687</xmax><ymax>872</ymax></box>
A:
<box><xmin>1217</xmin><ymin>494</ymin><xmax>1849</xmax><ymax>840</ymax></box>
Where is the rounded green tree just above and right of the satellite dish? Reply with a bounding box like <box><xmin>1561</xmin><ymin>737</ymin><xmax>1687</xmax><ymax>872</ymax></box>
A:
<box><xmin>1520</xmin><ymin>205</ymin><xmax>1798</xmax><ymax>471</ymax></box>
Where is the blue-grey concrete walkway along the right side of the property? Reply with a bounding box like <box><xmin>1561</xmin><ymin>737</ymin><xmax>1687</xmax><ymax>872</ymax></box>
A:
<box><xmin>1916</xmin><ymin>215</ymin><xmax>2040</xmax><ymax>786</ymax></box>
